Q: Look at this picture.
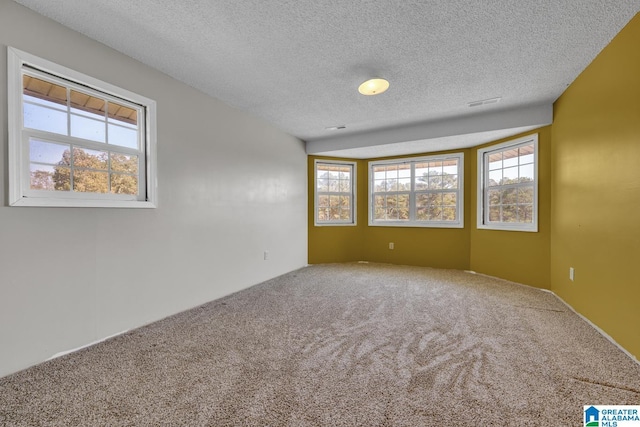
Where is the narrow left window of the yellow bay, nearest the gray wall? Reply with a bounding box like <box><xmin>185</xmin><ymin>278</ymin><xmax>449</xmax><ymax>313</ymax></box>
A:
<box><xmin>315</xmin><ymin>160</ymin><xmax>356</xmax><ymax>225</ymax></box>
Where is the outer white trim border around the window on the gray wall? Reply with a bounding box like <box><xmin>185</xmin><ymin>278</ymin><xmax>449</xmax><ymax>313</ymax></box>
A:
<box><xmin>7</xmin><ymin>46</ymin><xmax>158</xmax><ymax>208</ymax></box>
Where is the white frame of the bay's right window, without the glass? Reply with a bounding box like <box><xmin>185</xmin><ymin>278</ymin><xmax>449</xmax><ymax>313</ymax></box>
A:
<box><xmin>477</xmin><ymin>133</ymin><xmax>539</xmax><ymax>233</ymax></box>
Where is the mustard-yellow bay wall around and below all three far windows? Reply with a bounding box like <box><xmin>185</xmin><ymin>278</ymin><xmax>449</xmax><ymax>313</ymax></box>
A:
<box><xmin>309</xmin><ymin>134</ymin><xmax>551</xmax><ymax>289</ymax></box>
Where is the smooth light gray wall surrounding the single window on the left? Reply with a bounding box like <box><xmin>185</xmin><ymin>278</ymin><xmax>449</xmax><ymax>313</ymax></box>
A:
<box><xmin>0</xmin><ymin>0</ymin><xmax>307</xmax><ymax>376</ymax></box>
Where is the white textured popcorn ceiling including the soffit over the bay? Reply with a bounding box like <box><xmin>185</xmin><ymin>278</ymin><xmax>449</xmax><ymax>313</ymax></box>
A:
<box><xmin>16</xmin><ymin>0</ymin><xmax>640</xmax><ymax>158</ymax></box>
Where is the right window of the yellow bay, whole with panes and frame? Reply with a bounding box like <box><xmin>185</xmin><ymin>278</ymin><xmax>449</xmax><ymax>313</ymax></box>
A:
<box><xmin>478</xmin><ymin>134</ymin><xmax>538</xmax><ymax>232</ymax></box>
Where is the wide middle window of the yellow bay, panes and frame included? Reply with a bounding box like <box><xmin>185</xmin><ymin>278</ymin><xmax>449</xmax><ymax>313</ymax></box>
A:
<box><xmin>369</xmin><ymin>153</ymin><xmax>464</xmax><ymax>228</ymax></box>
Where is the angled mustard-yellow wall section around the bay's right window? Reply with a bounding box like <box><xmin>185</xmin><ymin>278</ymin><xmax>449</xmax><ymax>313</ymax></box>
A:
<box><xmin>467</xmin><ymin>126</ymin><xmax>551</xmax><ymax>289</ymax></box>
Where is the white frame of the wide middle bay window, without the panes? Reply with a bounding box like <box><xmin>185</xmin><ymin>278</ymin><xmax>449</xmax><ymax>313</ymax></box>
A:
<box><xmin>369</xmin><ymin>153</ymin><xmax>464</xmax><ymax>228</ymax></box>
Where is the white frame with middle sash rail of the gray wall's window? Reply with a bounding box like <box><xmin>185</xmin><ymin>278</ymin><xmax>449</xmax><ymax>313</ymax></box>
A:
<box><xmin>7</xmin><ymin>47</ymin><xmax>157</xmax><ymax>208</ymax></box>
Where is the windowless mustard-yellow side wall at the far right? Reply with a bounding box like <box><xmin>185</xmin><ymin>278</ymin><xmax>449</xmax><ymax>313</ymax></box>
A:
<box><xmin>551</xmin><ymin>14</ymin><xmax>640</xmax><ymax>358</ymax></box>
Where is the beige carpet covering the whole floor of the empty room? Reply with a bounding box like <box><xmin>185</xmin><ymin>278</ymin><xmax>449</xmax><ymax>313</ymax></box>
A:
<box><xmin>0</xmin><ymin>264</ymin><xmax>640</xmax><ymax>427</ymax></box>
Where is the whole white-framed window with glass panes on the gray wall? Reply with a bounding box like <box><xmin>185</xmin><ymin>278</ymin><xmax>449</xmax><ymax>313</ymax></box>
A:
<box><xmin>8</xmin><ymin>48</ymin><xmax>156</xmax><ymax>207</ymax></box>
